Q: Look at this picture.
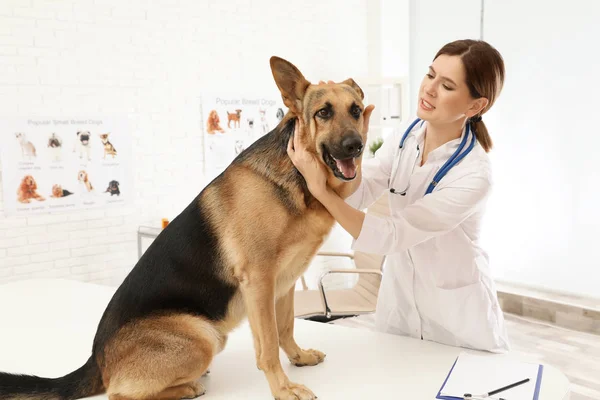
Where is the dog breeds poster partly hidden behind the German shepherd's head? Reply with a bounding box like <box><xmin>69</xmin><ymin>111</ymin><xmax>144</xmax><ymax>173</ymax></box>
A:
<box><xmin>202</xmin><ymin>93</ymin><xmax>287</xmax><ymax>177</ymax></box>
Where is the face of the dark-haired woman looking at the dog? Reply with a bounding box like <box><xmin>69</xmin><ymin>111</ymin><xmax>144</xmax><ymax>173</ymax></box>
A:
<box><xmin>417</xmin><ymin>55</ymin><xmax>487</xmax><ymax>124</ymax></box>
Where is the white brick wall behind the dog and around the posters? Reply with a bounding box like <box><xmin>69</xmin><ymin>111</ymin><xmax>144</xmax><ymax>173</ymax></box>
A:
<box><xmin>0</xmin><ymin>0</ymin><xmax>368</xmax><ymax>284</ymax></box>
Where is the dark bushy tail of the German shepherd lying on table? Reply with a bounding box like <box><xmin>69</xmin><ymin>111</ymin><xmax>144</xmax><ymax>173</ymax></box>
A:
<box><xmin>0</xmin><ymin>357</ymin><xmax>105</xmax><ymax>400</ymax></box>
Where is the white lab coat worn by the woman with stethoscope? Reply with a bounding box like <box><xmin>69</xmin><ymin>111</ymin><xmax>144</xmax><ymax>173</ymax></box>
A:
<box><xmin>346</xmin><ymin>119</ymin><xmax>510</xmax><ymax>352</ymax></box>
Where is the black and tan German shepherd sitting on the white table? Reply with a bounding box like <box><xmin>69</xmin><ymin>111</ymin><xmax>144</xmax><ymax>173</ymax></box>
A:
<box><xmin>0</xmin><ymin>57</ymin><xmax>371</xmax><ymax>400</ymax></box>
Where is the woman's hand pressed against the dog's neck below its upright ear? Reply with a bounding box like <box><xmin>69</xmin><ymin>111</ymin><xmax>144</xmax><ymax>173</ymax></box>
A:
<box><xmin>287</xmin><ymin>118</ymin><xmax>327</xmax><ymax>199</ymax></box>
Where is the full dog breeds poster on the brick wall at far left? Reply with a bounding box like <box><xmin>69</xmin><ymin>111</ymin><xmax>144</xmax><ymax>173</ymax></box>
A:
<box><xmin>0</xmin><ymin>117</ymin><xmax>132</xmax><ymax>216</ymax></box>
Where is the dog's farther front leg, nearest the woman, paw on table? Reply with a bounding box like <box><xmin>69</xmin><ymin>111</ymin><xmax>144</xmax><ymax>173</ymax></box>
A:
<box><xmin>276</xmin><ymin>286</ymin><xmax>325</xmax><ymax>367</ymax></box>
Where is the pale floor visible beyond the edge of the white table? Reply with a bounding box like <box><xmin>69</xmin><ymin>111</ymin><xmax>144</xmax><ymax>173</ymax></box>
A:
<box><xmin>333</xmin><ymin>314</ymin><xmax>600</xmax><ymax>400</ymax></box>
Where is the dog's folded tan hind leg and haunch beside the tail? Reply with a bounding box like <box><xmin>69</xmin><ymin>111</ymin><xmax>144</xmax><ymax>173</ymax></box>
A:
<box><xmin>102</xmin><ymin>314</ymin><xmax>221</xmax><ymax>400</ymax></box>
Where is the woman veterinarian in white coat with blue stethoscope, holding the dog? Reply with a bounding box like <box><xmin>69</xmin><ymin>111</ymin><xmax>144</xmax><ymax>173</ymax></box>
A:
<box><xmin>288</xmin><ymin>40</ymin><xmax>509</xmax><ymax>352</ymax></box>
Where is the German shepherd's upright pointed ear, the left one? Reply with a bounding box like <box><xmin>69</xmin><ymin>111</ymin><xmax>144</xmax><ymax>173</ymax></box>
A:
<box><xmin>270</xmin><ymin>56</ymin><xmax>310</xmax><ymax>115</ymax></box>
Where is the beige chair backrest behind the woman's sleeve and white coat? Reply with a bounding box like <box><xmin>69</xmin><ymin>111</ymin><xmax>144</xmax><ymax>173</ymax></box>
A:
<box><xmin>354</xmin><ymin>190</ymin><xmax>390</xmax><ymax>300</ymax></box>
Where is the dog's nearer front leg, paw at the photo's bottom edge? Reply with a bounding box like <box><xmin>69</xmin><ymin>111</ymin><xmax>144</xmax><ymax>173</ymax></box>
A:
<box><xmin>240</xmin><ymin>274</ymin><xmax>316</xmax><ymax>400</ymax></box>
